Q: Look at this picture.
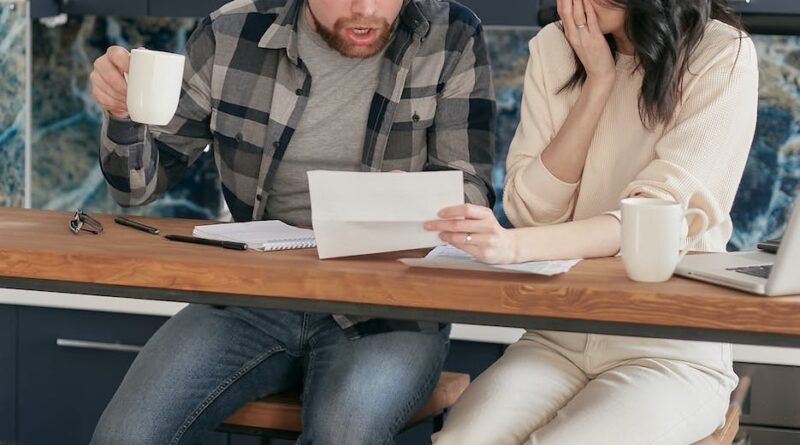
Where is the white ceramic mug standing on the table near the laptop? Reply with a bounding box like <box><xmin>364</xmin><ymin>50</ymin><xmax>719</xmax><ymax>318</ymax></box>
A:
<box><xmin>621</xmin><ymin>198</ymin><xmax>708</xmax><ymax>283</ymax></box>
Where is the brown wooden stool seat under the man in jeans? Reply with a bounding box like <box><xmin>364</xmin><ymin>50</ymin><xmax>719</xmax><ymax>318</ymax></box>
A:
<box><xmin>223</xmin><ymin>372</ymin><xmax>469</xmax><ymax>433</ymax></box>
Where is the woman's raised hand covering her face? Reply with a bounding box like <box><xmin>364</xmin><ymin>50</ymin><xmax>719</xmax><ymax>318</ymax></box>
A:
<box><xmin>557</xmin><ymin>0</ymin><xmax>616</xmax><ymax>85</ymax></box>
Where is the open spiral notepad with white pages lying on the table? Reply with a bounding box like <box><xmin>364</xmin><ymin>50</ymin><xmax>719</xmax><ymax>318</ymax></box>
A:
<box><xmin>192</xmin><ymin>221</ymin><xmax>317</xmax><ymax>250</ymax></box>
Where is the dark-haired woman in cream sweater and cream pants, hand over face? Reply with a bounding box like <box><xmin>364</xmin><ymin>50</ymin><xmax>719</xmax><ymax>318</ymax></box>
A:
<box><xmin>426</xmin><ymin>0</ymin><xmax>758</xmax><ymax>445</ymax></box>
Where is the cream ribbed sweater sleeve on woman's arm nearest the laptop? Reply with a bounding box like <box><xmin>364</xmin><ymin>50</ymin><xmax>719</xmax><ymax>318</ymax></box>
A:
<box><xmin>622</xmin><ymin>39</ymin><xmax>758</xmax><ymax>241</ymax></box>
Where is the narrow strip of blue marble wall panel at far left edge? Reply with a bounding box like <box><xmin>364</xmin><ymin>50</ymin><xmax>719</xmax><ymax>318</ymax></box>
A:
<box><xmin>0</xmin><ymin>1</ymin><xmax>27</xmax><ymax>207</ymax></box>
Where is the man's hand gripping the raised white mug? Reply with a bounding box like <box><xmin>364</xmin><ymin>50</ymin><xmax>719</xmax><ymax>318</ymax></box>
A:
<box><xmin>89</xmin><ymin>46</ymin><xmax>131</xmax><ymax>118</ymax></box>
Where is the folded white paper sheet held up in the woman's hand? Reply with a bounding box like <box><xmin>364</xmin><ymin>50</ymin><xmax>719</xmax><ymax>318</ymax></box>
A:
<box><xmin>308</xmin><ymin>170</ymin><xmax>464</xmax><ymax>259</ymax></box>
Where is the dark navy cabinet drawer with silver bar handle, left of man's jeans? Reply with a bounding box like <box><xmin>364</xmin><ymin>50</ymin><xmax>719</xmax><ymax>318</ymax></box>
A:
<box><xmin>17</xmin><ymin>307</ymin><xmax>166</xmax><ymax>445</ymax></box>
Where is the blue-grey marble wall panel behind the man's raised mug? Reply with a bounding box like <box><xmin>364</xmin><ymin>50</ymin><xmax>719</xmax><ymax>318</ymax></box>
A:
<box><xmin>32</xmin><ymin>16</ymin><xmax>222</xmax><ymax>219</ymax></box>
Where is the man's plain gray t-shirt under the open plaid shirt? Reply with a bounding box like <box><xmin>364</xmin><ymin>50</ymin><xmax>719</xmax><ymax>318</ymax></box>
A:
<box><xmin>267</xmin><ymin>13</ymin><xmax>383</xmax><ymax>227</ymax></box>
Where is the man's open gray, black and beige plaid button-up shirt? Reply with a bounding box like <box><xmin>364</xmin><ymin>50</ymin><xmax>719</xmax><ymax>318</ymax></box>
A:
<box><xmin>100</xmin><ymin>0</ymin><xmax>496</xmax><ymax>332</ymax></box>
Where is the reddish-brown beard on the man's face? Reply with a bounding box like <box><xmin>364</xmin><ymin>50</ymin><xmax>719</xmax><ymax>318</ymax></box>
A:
<box><xmin>307</xmin><ymin>5</ymin><xmax>395</xmax><ymax>59</ymax></box>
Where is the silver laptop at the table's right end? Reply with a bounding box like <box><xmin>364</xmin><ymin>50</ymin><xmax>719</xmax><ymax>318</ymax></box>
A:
<box><xmin>675</xmin><ymin>197</ymin><xmax>800</xmax><ymax>296</ymax></box>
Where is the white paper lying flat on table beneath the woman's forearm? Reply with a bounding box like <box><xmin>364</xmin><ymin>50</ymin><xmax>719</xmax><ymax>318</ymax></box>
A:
<box><xmin>400</xmin><ymin>245</ymin><xmax>581</xmax><ymax>276</ymax></box>
